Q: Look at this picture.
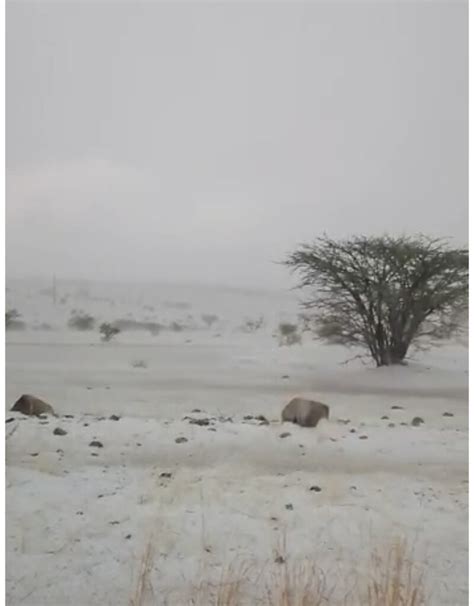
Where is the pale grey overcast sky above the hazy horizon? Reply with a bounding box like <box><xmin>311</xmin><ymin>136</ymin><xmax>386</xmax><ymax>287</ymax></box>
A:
<box><xmin>6</xmin><ymin>0</ymin><xmax>468</xmax><ymax>287</ymax></box>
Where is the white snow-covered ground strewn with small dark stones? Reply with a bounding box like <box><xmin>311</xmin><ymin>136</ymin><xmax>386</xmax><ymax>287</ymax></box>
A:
<box><xmin>6</xmin><ymin>283</ymin><xmax>468</xmax><ymax>606</ymax></box>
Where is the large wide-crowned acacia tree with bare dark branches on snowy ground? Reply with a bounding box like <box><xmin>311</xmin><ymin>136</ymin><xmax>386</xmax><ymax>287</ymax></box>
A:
<box><xmin>284</xmin><ymin>236</ymin><xmax>469</xmax><ymax>366</ymax></box>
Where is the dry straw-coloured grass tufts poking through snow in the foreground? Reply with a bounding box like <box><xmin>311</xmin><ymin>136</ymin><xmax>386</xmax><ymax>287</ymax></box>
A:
<box><xmin>130</xmin><ymin>541</ymin><xmax>427</xmax><ymax>606</ymax></box>
